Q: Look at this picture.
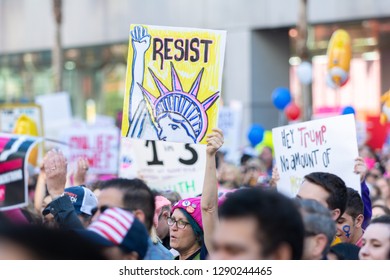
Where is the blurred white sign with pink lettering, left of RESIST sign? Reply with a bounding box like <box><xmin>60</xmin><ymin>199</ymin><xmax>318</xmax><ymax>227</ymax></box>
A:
<box><xmin>61</xmin><ymin>126</ymin><xmax>119</xmax><ymax>174</ymax></box>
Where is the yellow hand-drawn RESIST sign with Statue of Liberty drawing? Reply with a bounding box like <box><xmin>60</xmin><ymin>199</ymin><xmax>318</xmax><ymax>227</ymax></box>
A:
<box><xmin>122</xmin><ymin>25</ymin><xmax>226</xmax><ymax>144</ymax></box>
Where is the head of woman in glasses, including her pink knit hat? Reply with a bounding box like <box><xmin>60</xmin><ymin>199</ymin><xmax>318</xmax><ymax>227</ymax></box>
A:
<box><xmin>168</xmin><ymin>197</ymin><xmax>203</xmax><ymax>256</ymax></box>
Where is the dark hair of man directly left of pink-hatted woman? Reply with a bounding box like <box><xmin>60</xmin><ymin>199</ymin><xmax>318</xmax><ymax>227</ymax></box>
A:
<box><xmin>101</xmin><ymin>178</ymin><xmax>155</xmax><ymax>231</ymax></box>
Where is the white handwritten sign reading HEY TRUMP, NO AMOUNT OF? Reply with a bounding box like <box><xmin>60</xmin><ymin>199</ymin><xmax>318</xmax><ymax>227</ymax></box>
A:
<box><xmin>272</xmin><ymin>114</ymin><xmax>360</xmax><ymax>197</ymax></box>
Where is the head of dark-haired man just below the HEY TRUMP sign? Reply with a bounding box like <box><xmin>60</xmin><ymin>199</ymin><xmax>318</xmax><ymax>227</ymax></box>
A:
<box><xmin>297</xmin><ymin>172</ymin><xmax>347</xmax><ymax>221</ymax></box>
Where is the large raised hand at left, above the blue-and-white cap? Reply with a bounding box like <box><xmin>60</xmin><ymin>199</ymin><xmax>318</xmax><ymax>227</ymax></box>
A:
<box><xmin>43</xmin><ymin>150</ymin><xmax>67</xmax><ymax>199</ymax></box>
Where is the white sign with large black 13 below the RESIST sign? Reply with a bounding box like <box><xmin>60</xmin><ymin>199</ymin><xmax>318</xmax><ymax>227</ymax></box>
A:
<box><xmin>119</xmin><ymin>138</ymin><xmax>206</xmax><ymax>198</ymax></box>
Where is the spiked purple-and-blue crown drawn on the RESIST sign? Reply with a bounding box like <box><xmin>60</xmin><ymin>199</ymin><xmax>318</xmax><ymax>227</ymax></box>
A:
<box><xmin>138</xmin><ymin>62</ymin><xmax>218</xmax><ymax>141</ymax></box>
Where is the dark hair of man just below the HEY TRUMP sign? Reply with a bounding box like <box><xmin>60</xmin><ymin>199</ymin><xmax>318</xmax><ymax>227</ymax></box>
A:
<box><xmin>305</xmin><ymin>172</ymin><xmax>347</xmax><ymax>218</ymax></box>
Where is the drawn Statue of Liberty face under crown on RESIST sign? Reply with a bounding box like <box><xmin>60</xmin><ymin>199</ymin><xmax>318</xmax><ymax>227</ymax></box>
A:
<box><xmin>158</xmin><ymin>114</ymin><xmax>196</xmax><ymax>143</ymax></box>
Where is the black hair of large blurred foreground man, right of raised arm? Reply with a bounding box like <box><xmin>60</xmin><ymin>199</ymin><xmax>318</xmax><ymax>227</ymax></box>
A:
<box><xmin>219</xmin><ymin>188</ymin><xmax>304</xmax><ymax>260</ymax></box>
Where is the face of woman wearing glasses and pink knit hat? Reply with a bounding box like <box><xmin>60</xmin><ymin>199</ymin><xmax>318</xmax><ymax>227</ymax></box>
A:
<box><xmin>169</xmin><ymin>209</ymin><xmax>200</xmax><ymax>253</ymax></box>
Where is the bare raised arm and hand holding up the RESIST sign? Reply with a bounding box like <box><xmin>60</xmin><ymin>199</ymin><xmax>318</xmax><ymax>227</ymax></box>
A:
<box><xmin>201</xmin><ymin>128</ymin><xmax>223</xmax><ymax>254</ymax></box>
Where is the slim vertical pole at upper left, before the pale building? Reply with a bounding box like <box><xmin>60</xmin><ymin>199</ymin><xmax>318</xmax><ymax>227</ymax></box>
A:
<box><xmin>52</xmin><ymin>0</ymin><xmax>63</xmax><ymax>92</ymax></box>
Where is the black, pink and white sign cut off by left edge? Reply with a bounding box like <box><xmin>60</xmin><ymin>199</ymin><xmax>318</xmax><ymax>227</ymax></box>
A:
<box><xmin>0</xmin><ymin>133</ymin><xmax>40</xmax><ymax>211</ymax></box>
